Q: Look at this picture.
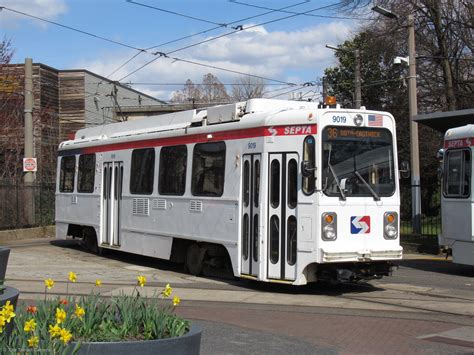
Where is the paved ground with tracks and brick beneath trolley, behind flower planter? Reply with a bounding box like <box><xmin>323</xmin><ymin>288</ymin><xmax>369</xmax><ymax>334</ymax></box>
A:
<box><xmin>3</xmin><ymin>241</ymin><xmax>474</xmax><ymax>354</ymax></box>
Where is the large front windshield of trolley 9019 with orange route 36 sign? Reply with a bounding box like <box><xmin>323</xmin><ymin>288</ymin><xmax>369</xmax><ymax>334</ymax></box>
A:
<box><xmin>322</xmin><ymin>126</ymin><xmax>396</xmax><ymax>200</ymax></box>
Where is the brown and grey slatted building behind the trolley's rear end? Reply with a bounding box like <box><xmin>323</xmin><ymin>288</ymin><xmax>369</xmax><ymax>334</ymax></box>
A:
<box><xmin>0</xmin><ymin>63</ymin><xmax>166</xmax><ymax>182</ymax></box>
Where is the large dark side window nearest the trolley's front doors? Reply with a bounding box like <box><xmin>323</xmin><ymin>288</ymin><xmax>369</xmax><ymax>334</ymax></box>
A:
<box><xmin>191</xmin><ymin>142</ymin><xmax>226</xmax><ymax>196</ymax></box>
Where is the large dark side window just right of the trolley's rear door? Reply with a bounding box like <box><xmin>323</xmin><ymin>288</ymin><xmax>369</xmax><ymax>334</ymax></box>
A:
<box><xmin>130</xmin><ymin>148</ymin><xmax>155</xmax><ymax>195</ymax></box>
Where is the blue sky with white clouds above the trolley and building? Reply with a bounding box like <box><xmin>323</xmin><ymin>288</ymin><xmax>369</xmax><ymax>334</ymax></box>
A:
<box><xmin>0</xmin><ymin>0</ymin><xmax>367</xmax><ymax>100</ymax></box>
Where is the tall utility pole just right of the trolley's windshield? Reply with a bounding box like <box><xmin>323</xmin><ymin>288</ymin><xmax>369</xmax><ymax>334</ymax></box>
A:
<box><xmin>408</xmin><ymin>15</ymin><xmax>421</xmax><ymax>234</ymax></box>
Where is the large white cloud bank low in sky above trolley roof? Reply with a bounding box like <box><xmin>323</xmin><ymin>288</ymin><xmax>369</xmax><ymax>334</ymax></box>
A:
<box><xmin>78</xmin><ymin>22</ymin><xmax>354</xmax><ymax>99</ymax></box>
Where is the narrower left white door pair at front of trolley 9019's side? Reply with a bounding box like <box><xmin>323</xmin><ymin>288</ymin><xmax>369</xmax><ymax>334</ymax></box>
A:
<box><xmin>241</xmin><ymin>154</ymin><xmax>261</xmax><ymax>276</ymax></box>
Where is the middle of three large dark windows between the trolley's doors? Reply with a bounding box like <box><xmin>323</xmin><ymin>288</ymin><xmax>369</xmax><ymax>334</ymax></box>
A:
<box><xmin>158</xmin><ymin>145</ymin><xmax>188</xmax><ymax>196</ymax></box>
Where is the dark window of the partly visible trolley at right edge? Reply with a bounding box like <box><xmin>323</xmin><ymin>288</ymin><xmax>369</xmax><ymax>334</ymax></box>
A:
<box><xmin>443</xmin><ymin>149</ymin><xmax>471</xmax><ymax>198</ymax></box>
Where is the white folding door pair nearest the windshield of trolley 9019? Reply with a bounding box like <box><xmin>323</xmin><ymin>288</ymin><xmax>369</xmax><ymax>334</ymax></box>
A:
<box><xmin>267</xmin><ymin>153</ymin><xmax>298</xmax><ymax>280</ymax></box>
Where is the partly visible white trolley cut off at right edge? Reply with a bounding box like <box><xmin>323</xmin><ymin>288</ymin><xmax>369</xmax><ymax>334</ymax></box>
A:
<box><xmin>438</xmin><ymin>124</ymin><xmax>474</xmax><ymax>265</ymax></box>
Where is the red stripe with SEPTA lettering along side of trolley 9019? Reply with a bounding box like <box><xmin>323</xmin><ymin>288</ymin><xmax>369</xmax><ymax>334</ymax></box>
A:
<box><xmin>80</xmin><ymin>124</ymin><xmax>317</xmax><ymax>154</ymax></box>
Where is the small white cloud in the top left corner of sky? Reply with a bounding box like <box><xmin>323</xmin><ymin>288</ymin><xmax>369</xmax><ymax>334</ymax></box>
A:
<box><xmin>0</xmin><ymin>0</ymin><xmax>67</xmax><ymax>27</ymax></box>
